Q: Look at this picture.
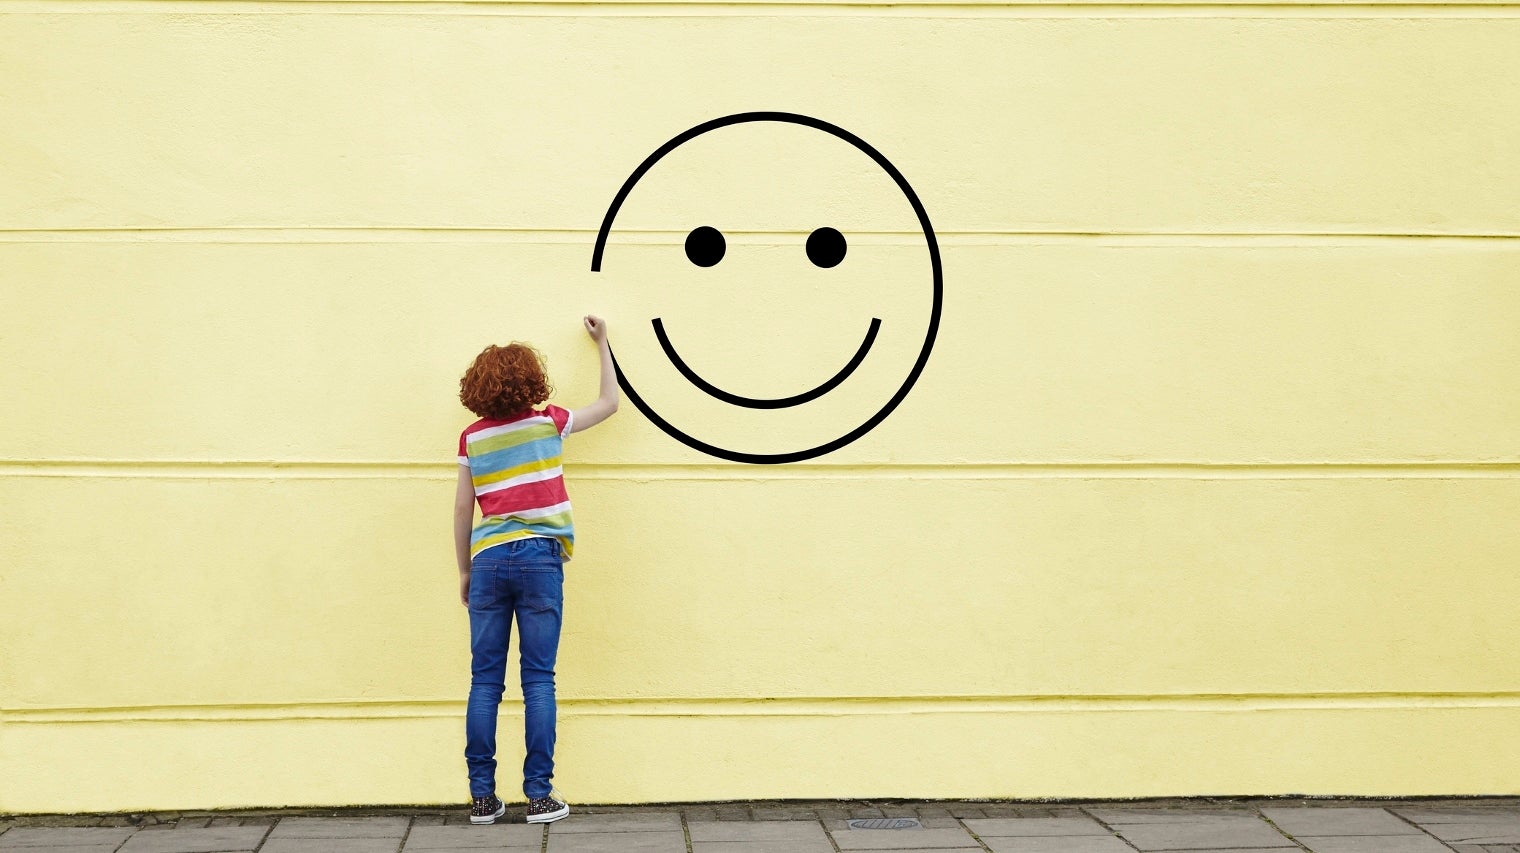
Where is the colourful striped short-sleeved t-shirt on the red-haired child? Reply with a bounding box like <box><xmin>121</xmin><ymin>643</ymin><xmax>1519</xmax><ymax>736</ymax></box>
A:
<box><xmin>459</xmin><ymin>406</ymin><xmax>575</xmax><ymax>560</ymax></box>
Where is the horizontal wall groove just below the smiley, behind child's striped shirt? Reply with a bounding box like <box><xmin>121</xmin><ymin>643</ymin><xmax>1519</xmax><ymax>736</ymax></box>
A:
<box><xmin>0</xmin><ymin>459</ymin><xmax>1520</xmax><ymax>482</ymax></box>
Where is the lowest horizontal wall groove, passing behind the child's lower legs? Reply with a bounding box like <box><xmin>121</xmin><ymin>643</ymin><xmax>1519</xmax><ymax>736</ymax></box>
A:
<box><xmin>0</xmin><ymin>692</ymin><xmax>1520</xmax><ymax>725</ymax></box>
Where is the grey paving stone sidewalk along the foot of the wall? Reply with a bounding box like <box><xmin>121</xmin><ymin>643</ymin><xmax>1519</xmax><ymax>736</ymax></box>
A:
<box><xmin>0</xmin><ymin>797</ymin><xmax>1520</xmax><ymax>853</ymax></box>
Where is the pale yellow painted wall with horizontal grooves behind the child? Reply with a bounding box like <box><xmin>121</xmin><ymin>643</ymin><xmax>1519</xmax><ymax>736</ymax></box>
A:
<box><xmin>0</xmin><ymin>0</ymin><xmax>1520</xmax><ymax>812</ymax></box>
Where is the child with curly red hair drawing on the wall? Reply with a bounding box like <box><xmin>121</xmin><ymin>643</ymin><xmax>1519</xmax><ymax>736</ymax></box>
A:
<box><xmin>454</xmin><ymin>316</ymin><xmax>617</xmax><ymax>824</ymax></box>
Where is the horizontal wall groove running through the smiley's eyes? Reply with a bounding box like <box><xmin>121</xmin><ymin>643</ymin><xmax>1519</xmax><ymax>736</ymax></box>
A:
<box><xmin>0</xmin><ymin>227</ymin><xmax>1520</xmax><ymax>244</ymax></box>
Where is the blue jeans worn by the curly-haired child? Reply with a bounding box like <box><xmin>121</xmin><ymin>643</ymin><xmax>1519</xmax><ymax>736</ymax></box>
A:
<box><xmin>465</xmin><ymin>537</ymin><xmax>564</xmax><ymax>800</ymax></box>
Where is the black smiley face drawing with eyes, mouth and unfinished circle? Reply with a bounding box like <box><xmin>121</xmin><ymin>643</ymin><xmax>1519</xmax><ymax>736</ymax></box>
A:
<box><xmin>591</xmin><ymin>111</ymin><xmax>944</xmax><ymax>464</ymax></box>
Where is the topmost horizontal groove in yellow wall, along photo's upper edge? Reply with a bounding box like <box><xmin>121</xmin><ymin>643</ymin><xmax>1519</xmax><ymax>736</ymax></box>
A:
<box><xmin>0</xmin><ymin>0</ymin><xmax>1520</xmax><ymax>18</ymax></box>
